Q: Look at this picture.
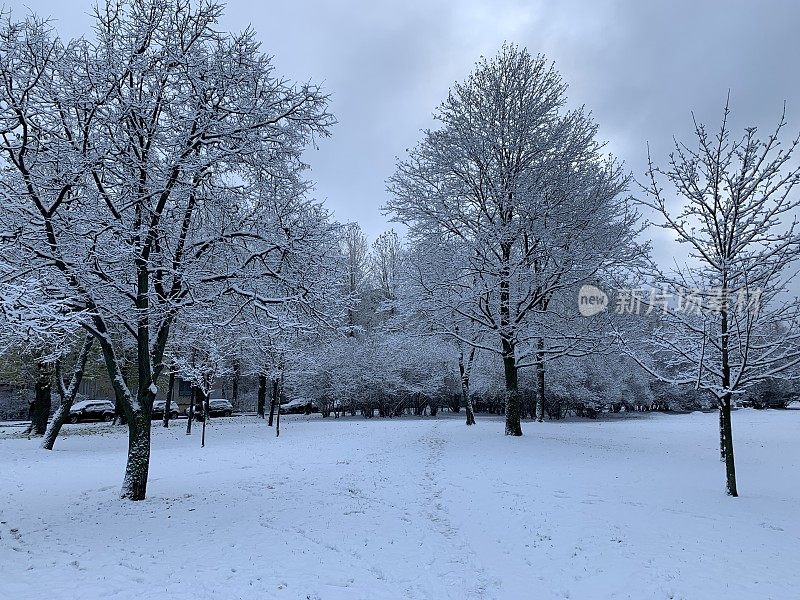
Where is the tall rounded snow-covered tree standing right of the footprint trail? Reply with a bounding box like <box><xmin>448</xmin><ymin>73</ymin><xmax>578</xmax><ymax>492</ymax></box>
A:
<box><xmin>387</xmin><ymin>45</ymin><xmax>636</xmax><ymax>435</ymax></box>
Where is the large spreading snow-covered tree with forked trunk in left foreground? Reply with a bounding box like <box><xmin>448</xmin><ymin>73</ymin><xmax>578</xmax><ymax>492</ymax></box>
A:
<box><xmin>0</xmin><ymin>0</ymin><xmax>333</xmax><ymax>500</ymax></box>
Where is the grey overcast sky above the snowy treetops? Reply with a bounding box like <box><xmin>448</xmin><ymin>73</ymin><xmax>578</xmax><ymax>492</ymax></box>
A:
<box><xmin>9</xmin><ymin>0</ymin><xmax>800</xmax><ymax>248</ymax></box>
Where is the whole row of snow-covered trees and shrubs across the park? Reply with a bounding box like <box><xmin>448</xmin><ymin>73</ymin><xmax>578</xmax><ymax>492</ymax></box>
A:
<box><xmin>0</xmin><ymin>0</ymin><xmax>800</xmax><ymax>500</ymax></box>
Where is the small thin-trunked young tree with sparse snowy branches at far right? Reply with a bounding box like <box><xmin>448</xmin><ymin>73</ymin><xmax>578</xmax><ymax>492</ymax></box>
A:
<box><xmin>638</xmin><ymin>104</ymin><xmax>800</xmax><ymax>496</ymax></box>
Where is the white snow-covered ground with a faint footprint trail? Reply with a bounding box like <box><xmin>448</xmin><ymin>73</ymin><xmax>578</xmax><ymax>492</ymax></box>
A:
<box><xmin>0</xmin><ymin>410</ymin><xmax>800</xmax><ymax>600</ymax></box>
